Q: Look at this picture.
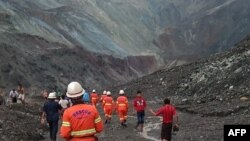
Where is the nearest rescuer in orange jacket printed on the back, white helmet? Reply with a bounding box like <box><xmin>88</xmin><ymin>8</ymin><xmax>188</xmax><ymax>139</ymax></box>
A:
<box><xmin>60</xmin><ymin>82</ymin><xmax>103</xmax><ymax>141</ymax></box>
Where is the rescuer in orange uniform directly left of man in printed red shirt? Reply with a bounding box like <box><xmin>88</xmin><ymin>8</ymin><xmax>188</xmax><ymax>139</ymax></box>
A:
<box><xmin>116</xmin><ymin>90</ymin><xmax>128</xmax><ymax>127</ymax></box>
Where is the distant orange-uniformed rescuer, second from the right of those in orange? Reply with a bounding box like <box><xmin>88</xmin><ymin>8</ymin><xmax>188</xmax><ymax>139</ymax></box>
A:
<box><xmin>102</xmin><ymin>91</ymin><xmax>115</xmax><ymax>124</ymax></box>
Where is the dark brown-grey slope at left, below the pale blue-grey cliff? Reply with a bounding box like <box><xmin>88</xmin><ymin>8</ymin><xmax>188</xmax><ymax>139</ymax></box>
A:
<box><xmin>0</xmin><ymin>34</ymin><xmax>156</xmax><ymax>90</ymax></box>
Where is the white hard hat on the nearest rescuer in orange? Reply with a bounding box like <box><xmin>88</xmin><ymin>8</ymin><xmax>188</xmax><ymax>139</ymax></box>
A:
<box><xmin>66</xmin><ymin>82</ymin><xmax>85</xmax><ymax>98</ymax></box>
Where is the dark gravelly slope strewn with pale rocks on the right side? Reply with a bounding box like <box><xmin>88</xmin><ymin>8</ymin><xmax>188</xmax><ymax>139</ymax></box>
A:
<box><xmin>114</xmin><ymin>37</ymin><xmax>250</xmax><ymax>115</ymax></box>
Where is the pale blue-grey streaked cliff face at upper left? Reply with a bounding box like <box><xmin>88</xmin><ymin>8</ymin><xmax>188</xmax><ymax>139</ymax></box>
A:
<box><xmin>1</xmin><ymin>0</ymin><xmax>160</xmax><ymax>58</ymax></box>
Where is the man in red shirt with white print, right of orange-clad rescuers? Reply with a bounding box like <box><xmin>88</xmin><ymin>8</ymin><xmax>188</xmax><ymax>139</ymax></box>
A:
<box><xmin>133</xmin><ymin>90</ymin><xmax>147</xmax><ymax>132</ymax></box>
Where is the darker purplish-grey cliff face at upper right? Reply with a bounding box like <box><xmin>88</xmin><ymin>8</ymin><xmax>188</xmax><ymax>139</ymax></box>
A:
<box><xmin>154</xmin><ymin>0</ymin><xmax>250</xmax><ymax>60</ymax></box>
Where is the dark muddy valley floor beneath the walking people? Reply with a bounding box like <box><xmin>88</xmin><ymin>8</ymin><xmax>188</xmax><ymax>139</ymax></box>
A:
<box><xmin>0</xmin><ymin>96</ymin><xmax>250</xmax><ymax>141</ymax></box>
